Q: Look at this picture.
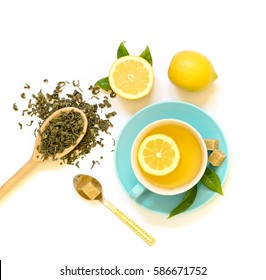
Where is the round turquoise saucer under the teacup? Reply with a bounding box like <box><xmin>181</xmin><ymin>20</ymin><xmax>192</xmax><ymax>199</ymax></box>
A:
<box><xmin>115</xmin><ymin>101</ymin><xmax>228</xmax><ymax>214</ymax></box>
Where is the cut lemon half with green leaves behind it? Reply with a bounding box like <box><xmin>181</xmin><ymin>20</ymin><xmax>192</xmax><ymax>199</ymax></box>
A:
<box><xmin>109</xmin><ymin>55</ymin><xmax>154</xmax><ymax>99</ymax></box>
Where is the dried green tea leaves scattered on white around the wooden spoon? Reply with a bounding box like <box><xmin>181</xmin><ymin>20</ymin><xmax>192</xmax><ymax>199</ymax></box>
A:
<box><xmin>13</xmin><ymin>80</ymin><xmax>116</xmax><ymax>165</ymax></box>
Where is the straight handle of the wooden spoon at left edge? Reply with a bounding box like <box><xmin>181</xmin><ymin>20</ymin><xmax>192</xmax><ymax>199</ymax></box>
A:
<box><xmin>0</xmin><ymin>159</ymin><xmax>36</xmax><ymax>199</ymax></box>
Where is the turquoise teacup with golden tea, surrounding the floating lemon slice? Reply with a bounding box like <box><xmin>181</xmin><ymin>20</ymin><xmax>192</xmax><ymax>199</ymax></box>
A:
<box><xmin>130</xmin><ymin>119</ymin><xmax>208</xmax><ymax>199</ymax></box>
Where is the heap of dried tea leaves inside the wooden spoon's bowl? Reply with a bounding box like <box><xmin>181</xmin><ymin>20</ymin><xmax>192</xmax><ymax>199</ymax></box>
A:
<box><xmin>37</xmin><ymin>111</ymin><xmax>84</xmax><ymax>160</ymax></box>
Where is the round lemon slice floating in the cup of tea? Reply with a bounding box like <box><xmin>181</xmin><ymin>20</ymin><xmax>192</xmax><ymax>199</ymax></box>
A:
<box><xmin>138</xmin><ymin>134</ymin><xmax>180</xmax><ymax>176</ymax></box>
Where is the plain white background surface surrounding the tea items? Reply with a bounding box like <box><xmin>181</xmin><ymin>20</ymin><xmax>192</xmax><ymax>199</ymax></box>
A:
<box><xmin>0</xmin><ymin>0</ymin><xmax>266</xmax><ymax>280</ymax></box>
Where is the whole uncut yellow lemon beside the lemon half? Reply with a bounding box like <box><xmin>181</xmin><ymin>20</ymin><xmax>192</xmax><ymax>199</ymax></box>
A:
<box><xmin>168</xmin><ymin>50</ymin><xmax>218</xmax><ymax>91</ymax></box>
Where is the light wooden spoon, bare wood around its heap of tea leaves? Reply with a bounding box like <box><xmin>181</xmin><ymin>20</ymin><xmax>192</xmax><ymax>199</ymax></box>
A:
<box><xmin>0</xmin><ymin>107</ymin><xmax>88</xmax><ymax>198</ymax></box>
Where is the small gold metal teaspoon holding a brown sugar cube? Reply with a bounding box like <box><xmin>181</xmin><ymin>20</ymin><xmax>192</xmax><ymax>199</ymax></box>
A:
<box><xmin>73</xmin><ymin>174</ymin><xmax>155</xmax><ymax>246</ymax></box>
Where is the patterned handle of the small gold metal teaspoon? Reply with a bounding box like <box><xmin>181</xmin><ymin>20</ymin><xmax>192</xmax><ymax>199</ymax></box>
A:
<box><xmin>101</xmin><ymin>199</ymin><xmax>155</xmax><ymax>246</ymax></box>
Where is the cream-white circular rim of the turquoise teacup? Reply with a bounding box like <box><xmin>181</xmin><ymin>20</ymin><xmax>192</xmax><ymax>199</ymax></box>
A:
<box><xmin>130</xmin><ymin>118</ymin><xmax>208</xmax><ymax>195</ymax></box>
